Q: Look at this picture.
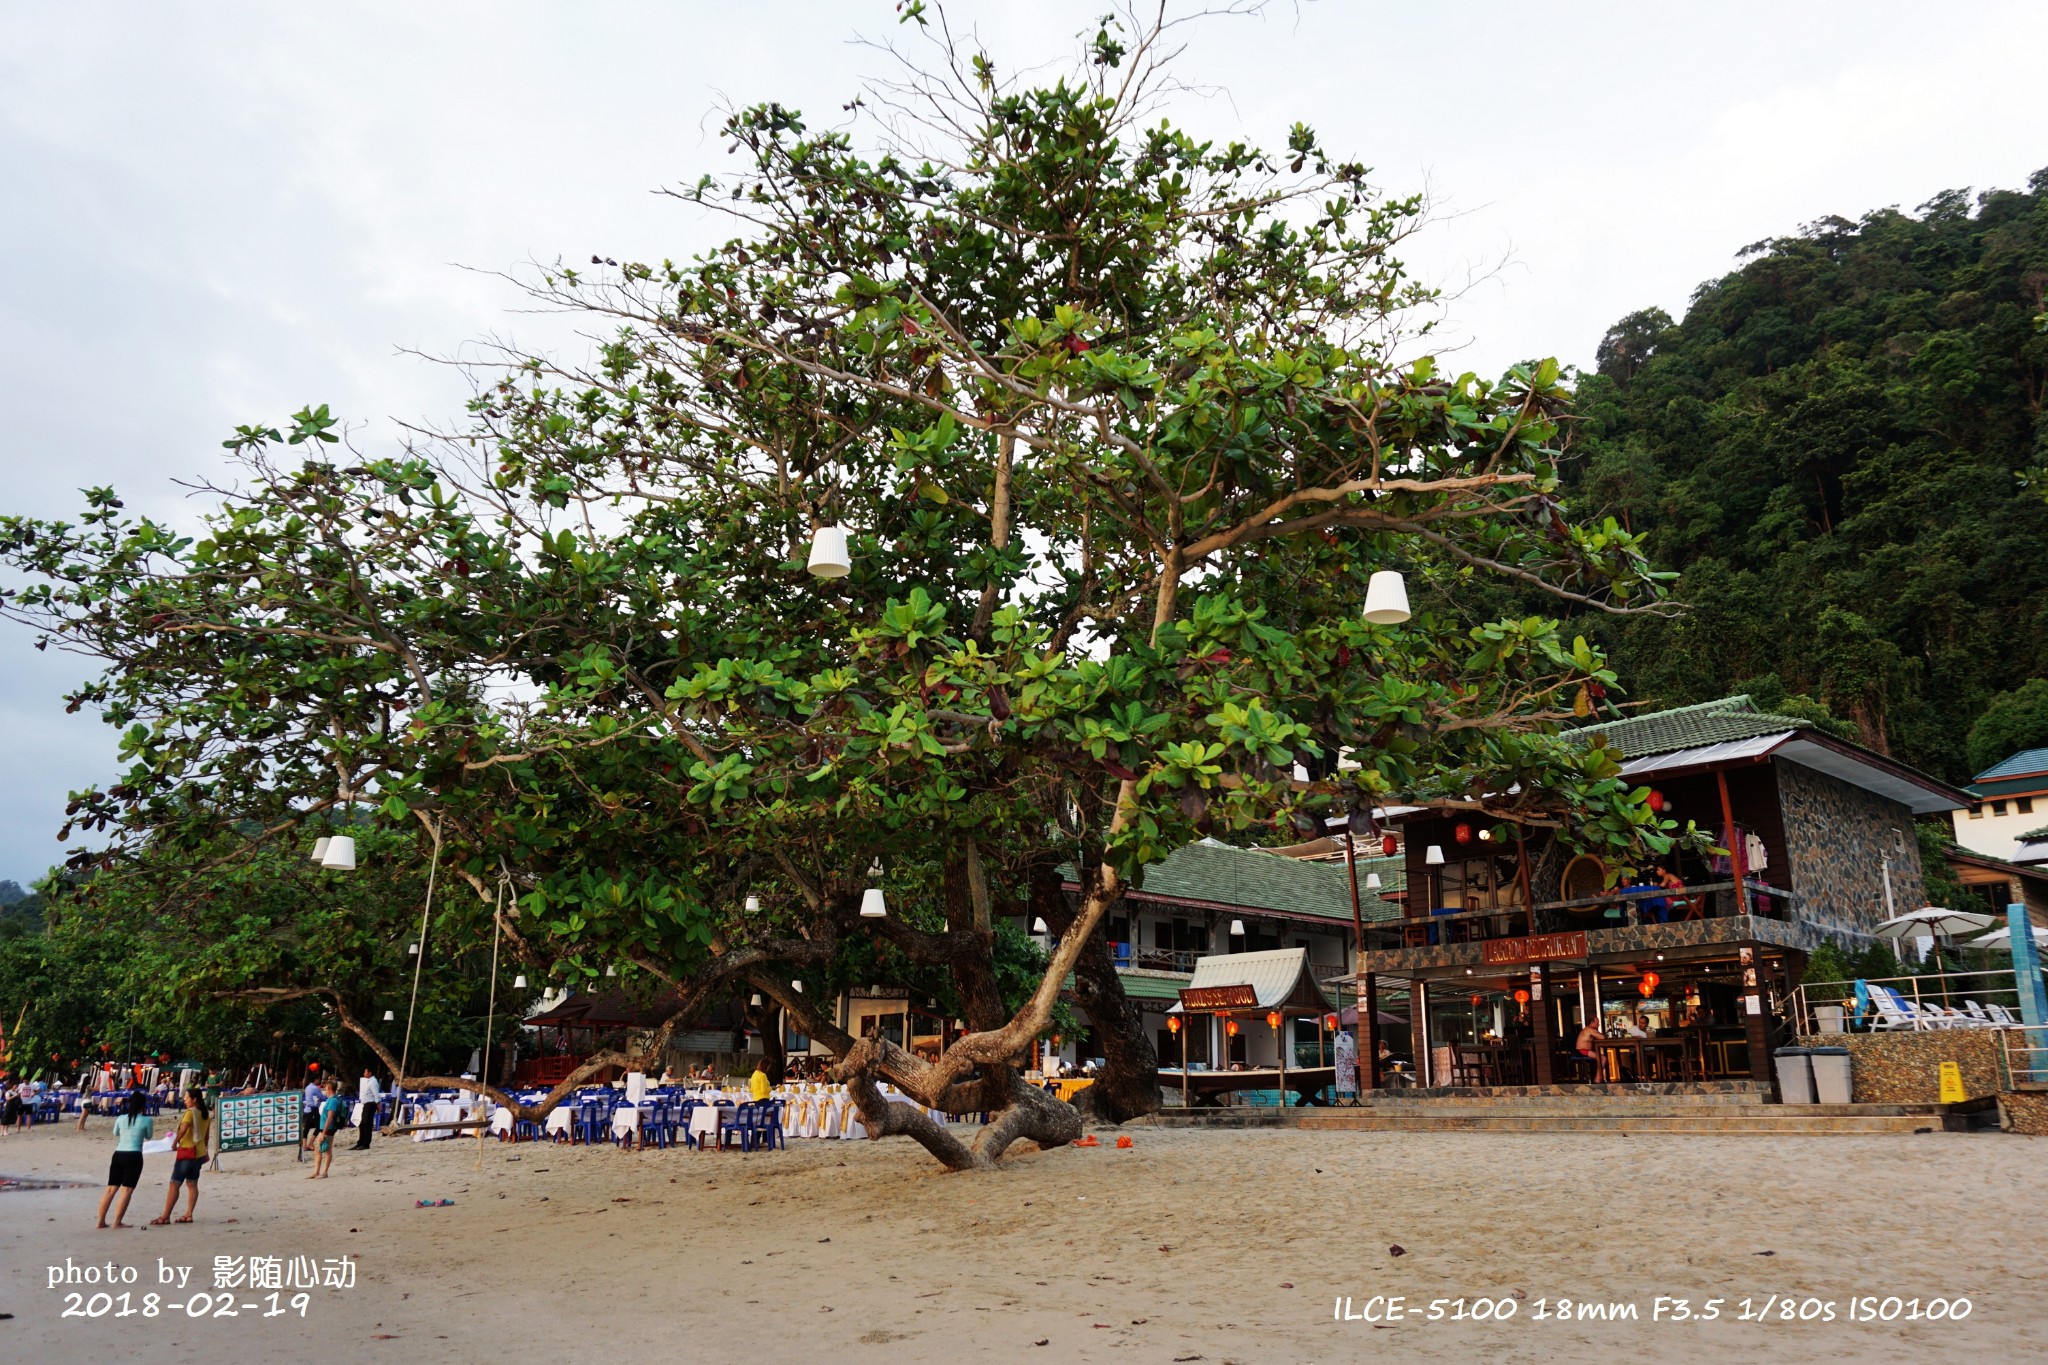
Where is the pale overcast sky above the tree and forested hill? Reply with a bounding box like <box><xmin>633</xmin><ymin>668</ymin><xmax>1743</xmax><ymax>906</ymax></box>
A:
<box><xmin>0</xmin><ymin>0</ymin><xmax>2048</xmax><ymax>882</ymax></box>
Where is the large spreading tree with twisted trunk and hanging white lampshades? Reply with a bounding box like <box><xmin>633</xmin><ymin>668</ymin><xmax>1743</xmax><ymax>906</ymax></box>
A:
<box><xmin>4</xmin><ymin>6</ymin><xmax>1669</xmax><ymax>1169</ymax></box>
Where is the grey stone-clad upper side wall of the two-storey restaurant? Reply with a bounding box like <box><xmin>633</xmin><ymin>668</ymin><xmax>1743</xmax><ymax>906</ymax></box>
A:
<box><xmin>1778</xmin><ymin>761</ymin><xmax>1927</xmax><ymax>935</ymax></box>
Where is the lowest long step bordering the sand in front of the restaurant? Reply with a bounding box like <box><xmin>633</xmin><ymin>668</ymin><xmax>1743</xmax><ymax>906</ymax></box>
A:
<box><xmin>1290</xmin><ymin>1105</ymin><xmax>1968</xmax><ymax>1136</ymax></box>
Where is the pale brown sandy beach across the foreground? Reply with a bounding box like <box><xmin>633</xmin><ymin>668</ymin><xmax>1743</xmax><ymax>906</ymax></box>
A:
<box><xmin>0</xmin><ymin>1124</ymin><xmax>2048</xmax><ymax>1365</ymax></box>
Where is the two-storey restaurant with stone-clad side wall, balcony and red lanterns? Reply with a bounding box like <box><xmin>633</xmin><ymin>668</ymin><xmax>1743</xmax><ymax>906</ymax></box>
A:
<box><xmin>1356</xmin><ymin>696</ymin><xmax>1968</xmax><ymax>1087</ymax></box>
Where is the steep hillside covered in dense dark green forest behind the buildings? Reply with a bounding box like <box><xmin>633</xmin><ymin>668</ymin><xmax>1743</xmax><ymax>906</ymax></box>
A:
<box><xmin>1567</xmin><ymin>170</ymin><xmax>2048</xmax><ymax>780</ymax></box>
